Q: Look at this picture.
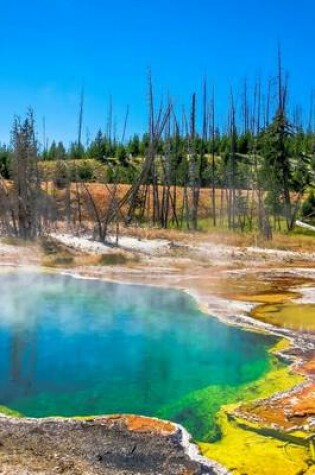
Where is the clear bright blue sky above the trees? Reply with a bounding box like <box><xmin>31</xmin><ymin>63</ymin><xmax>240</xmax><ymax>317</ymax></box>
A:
<box><xmin>0</xmin><ymin>0</ymin><xmax>315</xmax><ymax>147</ymax></box>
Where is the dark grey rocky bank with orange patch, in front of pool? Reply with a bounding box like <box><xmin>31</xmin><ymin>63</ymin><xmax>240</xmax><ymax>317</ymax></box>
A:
<box><xmin>0</xmin><ymin>415</ymin><xmax>228</xmax><ymax>475</ymax></box>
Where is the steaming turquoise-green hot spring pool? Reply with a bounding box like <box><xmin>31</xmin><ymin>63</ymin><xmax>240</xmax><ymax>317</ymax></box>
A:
<box><xmin>0</xmin><ymin>272</ymin><xmax>275</xmax><ymax>437</ymax></box>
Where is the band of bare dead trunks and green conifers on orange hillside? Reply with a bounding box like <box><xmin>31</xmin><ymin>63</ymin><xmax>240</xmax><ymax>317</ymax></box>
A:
<box><xmin>0</xmin><ymin>56</ymin><xmax>315</xmax><ymax>241</ymax></box>
